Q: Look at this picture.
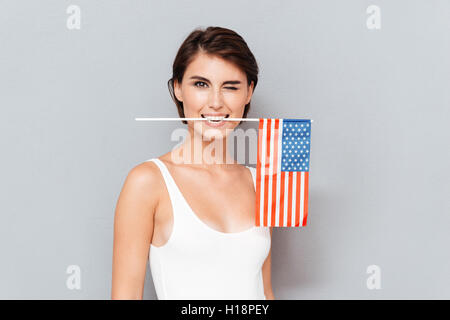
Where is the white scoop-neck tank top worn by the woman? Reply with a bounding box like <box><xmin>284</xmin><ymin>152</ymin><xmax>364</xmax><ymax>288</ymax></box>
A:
<box><xmin>147</xmin><ymin>158</ymin><xmax>271</xmax><ymax>300</ymax></box>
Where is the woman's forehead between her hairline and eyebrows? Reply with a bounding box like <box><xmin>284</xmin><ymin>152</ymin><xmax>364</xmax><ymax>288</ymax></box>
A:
<box><xmin>184</xmin><ymin>53</ymin><xmax>246</xmax><ymax>81</ymax></box>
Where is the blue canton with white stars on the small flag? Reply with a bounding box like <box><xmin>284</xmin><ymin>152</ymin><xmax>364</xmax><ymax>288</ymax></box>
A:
<box><xmin>281</xmin><ymin>119</ymin><xmax>311</xmax><ymax>171</ymax></box>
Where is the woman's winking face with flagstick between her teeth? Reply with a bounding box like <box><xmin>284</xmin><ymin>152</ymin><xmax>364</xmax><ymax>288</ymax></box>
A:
<box><xmin>174</xmin><ymin>53</ymin><xmax>253</xmax><ymax>140</ymax></box>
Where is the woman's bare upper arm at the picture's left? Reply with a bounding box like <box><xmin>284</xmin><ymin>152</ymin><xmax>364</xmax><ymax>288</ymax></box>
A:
<box><xmin>111</xmin><ymin>163</ymin><xmax>160</xmax><ymax>299</ymax></box>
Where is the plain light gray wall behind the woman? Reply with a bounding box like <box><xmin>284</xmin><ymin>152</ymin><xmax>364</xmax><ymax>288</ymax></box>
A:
<box><xmin>0</xmin><ymin>0</ymin><xmax>450</xmax><ymax>299</ymax></box>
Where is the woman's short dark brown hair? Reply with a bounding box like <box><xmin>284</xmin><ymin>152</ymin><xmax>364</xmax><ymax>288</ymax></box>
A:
<box><xmin>167</xmin><ymin>27</ymin><xmax>259</xmax><ymax>124</ymax></box>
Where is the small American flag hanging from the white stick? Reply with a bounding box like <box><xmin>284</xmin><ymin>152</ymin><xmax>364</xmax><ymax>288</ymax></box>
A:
<box><xmin>256</xmin><ymin>118</ymin><xmax>311</xmax><ymax>227</ymax></box>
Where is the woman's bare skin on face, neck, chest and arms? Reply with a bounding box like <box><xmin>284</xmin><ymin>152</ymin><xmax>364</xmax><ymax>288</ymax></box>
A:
<box><xmin>111</xmin><ymin>52</ymin><xmax>275</xmax><ymax>300</ymax></box>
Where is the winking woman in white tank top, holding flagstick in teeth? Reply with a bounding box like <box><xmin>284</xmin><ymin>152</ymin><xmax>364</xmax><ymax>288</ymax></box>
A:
<box><xmin>112</xmin><ymin>27</ymin><xmax>274</xmax><ymax>299</ymax></box>
